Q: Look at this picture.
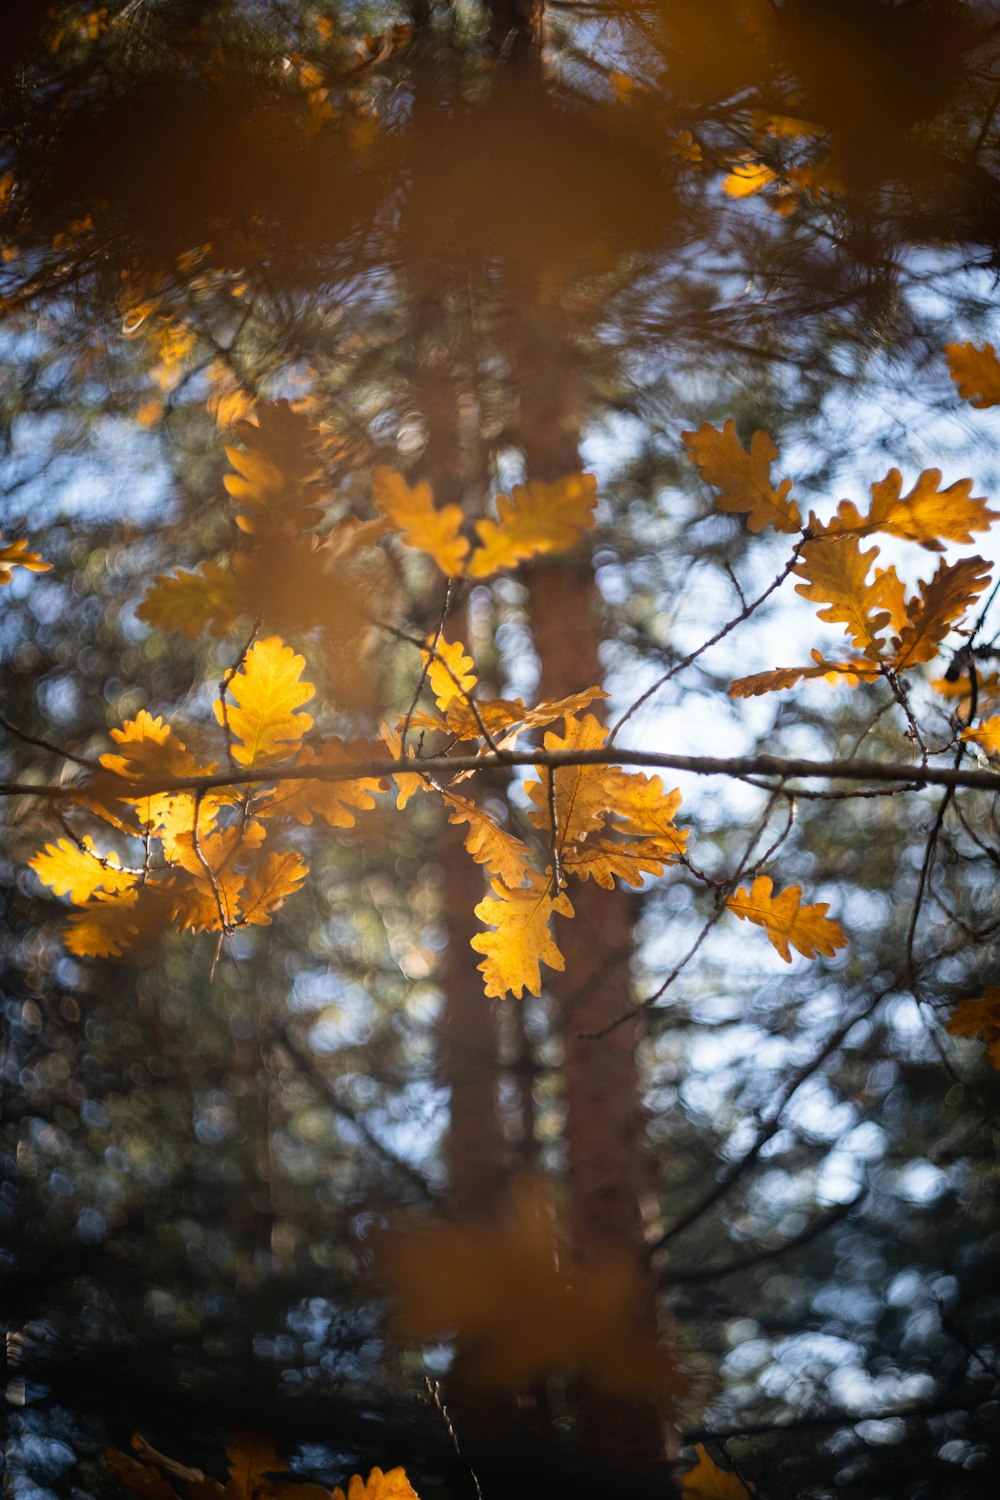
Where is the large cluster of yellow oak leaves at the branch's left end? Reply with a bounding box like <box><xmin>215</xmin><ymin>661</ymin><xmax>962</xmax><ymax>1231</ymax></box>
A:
<box><xmin>30</xmin><ymin>636</ymin><xmax>385</xmax><ymax>957</ymax></box>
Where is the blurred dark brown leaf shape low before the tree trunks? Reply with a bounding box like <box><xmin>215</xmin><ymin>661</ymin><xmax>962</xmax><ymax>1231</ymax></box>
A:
<box><xmin>376</xmin><ymin>1176</ymin><xmax>681</xmax><ymax>1397</ymax></box>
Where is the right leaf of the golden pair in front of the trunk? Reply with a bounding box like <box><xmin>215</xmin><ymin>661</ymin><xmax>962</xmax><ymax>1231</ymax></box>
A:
<box><xmin>469</xmin><ymin>474</ymin><xmax>597</xmax><ymax>578</ymax></box>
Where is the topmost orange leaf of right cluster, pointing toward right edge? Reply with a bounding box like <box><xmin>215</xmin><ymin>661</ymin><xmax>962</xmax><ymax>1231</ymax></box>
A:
<box><xmin>810</xmin><ymin>468</ymin><xmax>1000</xmax><ymax>552</ymax></box>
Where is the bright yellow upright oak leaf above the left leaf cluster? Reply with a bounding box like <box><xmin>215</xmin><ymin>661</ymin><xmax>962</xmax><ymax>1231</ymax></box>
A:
<box><xmin>214</xmin><ymin>636</ymin><xmax>313</xmax><ymax>767</ymax></box>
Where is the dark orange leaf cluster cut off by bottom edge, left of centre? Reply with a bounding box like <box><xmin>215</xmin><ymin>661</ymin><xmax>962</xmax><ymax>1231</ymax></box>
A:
<box><xmin>105</xmin><ymin>1428</ymin><xmax>420</xmax><ymax>1500</ymax></box>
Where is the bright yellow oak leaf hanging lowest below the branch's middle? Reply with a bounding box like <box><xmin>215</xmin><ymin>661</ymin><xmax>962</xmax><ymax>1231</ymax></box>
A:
<box><xmin>472</xmin><ymin>875</ymin><xmax>573</xmax><ymax>999</ymax></box>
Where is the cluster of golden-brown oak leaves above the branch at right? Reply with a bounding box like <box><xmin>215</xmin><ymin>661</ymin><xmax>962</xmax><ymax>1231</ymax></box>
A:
<box><xmin>684</xmin><ymin>422</ymin><xmax>1000</xmax><ymax>698</ymax></box>
